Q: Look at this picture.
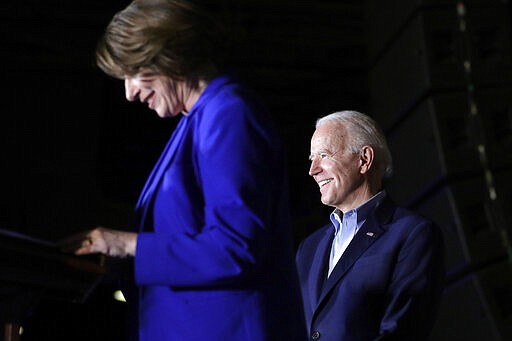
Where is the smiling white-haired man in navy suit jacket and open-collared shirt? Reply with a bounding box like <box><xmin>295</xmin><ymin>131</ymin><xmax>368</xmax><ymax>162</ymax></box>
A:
<box><xmin>297</xmin><ymin>111</ymin><xmax>444</xmax><ymax>341</ymax></box>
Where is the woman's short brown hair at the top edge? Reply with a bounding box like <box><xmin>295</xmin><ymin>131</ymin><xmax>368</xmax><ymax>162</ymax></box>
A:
<box><xmin>96</xmin><ymin>0</ymin><xmax>223</xmax><ymax>87</ymax></box>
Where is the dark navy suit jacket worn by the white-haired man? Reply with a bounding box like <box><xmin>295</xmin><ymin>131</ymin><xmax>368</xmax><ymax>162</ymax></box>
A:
<box><xmin>296</xmin><ymin>198</ymin><xmax>444</xmax><ymax>341</ymax></box>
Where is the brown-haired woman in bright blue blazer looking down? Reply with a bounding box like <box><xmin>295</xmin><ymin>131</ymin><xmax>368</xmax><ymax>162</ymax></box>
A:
<box><xmin>72</xmin><ymin>0</ymin><xmax>305</xmax><ymax>341</ymax></box>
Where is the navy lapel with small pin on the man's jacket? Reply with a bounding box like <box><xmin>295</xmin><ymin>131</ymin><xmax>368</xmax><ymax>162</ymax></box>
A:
<box><xmin>317</xmin><ymin>198</ymin><xmax>394</xmax><ymax>307</ymax></box>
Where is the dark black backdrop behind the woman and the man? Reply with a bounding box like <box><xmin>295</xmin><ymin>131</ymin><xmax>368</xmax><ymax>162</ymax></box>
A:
<box><xmin>0</xmin><ymin>0</ymin><xmax>512</xmax><ymax>340</ymax></box>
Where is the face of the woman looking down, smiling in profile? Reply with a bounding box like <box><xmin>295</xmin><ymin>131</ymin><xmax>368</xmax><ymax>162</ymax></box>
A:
<box><xmin>124</xmin><ymin>72</ymin><xmax>185</xmax><ymax>117</ymax></box>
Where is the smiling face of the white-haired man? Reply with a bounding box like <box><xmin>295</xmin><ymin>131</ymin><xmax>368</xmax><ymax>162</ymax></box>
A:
<box><xmin>309</xmin><ymin>123</ymin><xmax>364</xmax><ymax>212</ymax></box>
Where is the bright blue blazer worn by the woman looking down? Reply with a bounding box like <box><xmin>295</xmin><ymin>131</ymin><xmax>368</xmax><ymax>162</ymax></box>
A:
<box><xmin>131</xmin><ymin>76</ymin><xmax>305</xmax><ymax>341</ymax></box>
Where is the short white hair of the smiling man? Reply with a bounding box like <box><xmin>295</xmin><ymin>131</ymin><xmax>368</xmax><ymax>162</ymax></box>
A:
<box><xmin>316</xmin><ymin>110</ymin><xmax>393</xmax><ymax>177</ymax></box>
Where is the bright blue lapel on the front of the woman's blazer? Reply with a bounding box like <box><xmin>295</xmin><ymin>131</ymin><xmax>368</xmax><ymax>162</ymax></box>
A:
<box><xmin>135</xmin><ymin>117</ymin><xmax>188</xmax><ymax>231</ymax></box>
